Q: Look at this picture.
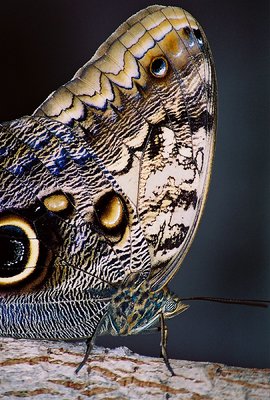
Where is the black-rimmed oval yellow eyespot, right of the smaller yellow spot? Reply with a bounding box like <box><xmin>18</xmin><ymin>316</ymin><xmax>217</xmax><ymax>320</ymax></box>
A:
<box><xmin>95</xmin><ymin>192</ymin><xmax>127</xmax><ymax>241</ymax></box>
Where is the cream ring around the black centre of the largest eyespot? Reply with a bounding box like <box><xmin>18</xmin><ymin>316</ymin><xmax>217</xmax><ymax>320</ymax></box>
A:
<box><xmin>0</xmin><ymin>215</ymin><xmax>39</xmax><ymax>286</ymax></box>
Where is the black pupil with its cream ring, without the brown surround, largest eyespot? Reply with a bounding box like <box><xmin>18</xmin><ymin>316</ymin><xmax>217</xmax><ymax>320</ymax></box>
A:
<box><xmin>0</xmin><ymin>214</ymin><xmax>40</xmax><ymax>287</ymax></box>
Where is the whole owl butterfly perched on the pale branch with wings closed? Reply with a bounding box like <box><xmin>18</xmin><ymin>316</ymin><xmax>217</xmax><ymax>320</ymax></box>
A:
<box><xmin>0</xmin><ymin>6</ymin><xmax>216</xmax><ymax>374</ymax></box>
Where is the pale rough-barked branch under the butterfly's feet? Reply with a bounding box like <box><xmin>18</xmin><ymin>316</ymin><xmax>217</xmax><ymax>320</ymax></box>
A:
<box><xmin>0</xmin><ymin>339</ymin><xmax>270</xmax><ymax>400</ymax></box>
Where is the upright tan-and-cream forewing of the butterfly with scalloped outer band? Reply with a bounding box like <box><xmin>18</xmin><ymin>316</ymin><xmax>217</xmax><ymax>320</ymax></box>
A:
<box><xmin>33</xmin><ymin>6</ymin><xmax>216</xmax><ymax>289</ymax></box>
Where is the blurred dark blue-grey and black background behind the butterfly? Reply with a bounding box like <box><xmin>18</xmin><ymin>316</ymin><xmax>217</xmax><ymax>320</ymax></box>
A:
<box><xmin>0</xmin><ymin>0</ymin><xmax>270</xmax><ymax>367</ymax></box>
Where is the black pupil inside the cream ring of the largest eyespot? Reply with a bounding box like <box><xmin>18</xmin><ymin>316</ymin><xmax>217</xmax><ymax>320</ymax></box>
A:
<box><xmin>0</xmin><ymin>225</ymin><xmax>29</xmax><ymax>278</ymax></box>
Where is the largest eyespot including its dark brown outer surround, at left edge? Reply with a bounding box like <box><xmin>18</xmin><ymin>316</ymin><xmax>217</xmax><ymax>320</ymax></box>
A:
<box><xmin>0</xmin><ymin>211</ymin><xmax>52</xmax><ymax>293</ymax></box>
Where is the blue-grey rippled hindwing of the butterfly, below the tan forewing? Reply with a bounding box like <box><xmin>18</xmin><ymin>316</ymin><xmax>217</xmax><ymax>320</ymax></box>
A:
<box><xmin>0</xmin><ymin>117</ymin><xmax>150</xmax><ymax>339</ymax></box>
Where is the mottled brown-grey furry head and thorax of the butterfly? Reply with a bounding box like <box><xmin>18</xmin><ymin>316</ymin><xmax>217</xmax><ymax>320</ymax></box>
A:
<box><xmin>102</xmin><ymin>281</ymin><xmax>188</xmax><ymax>335</ymax></box>
